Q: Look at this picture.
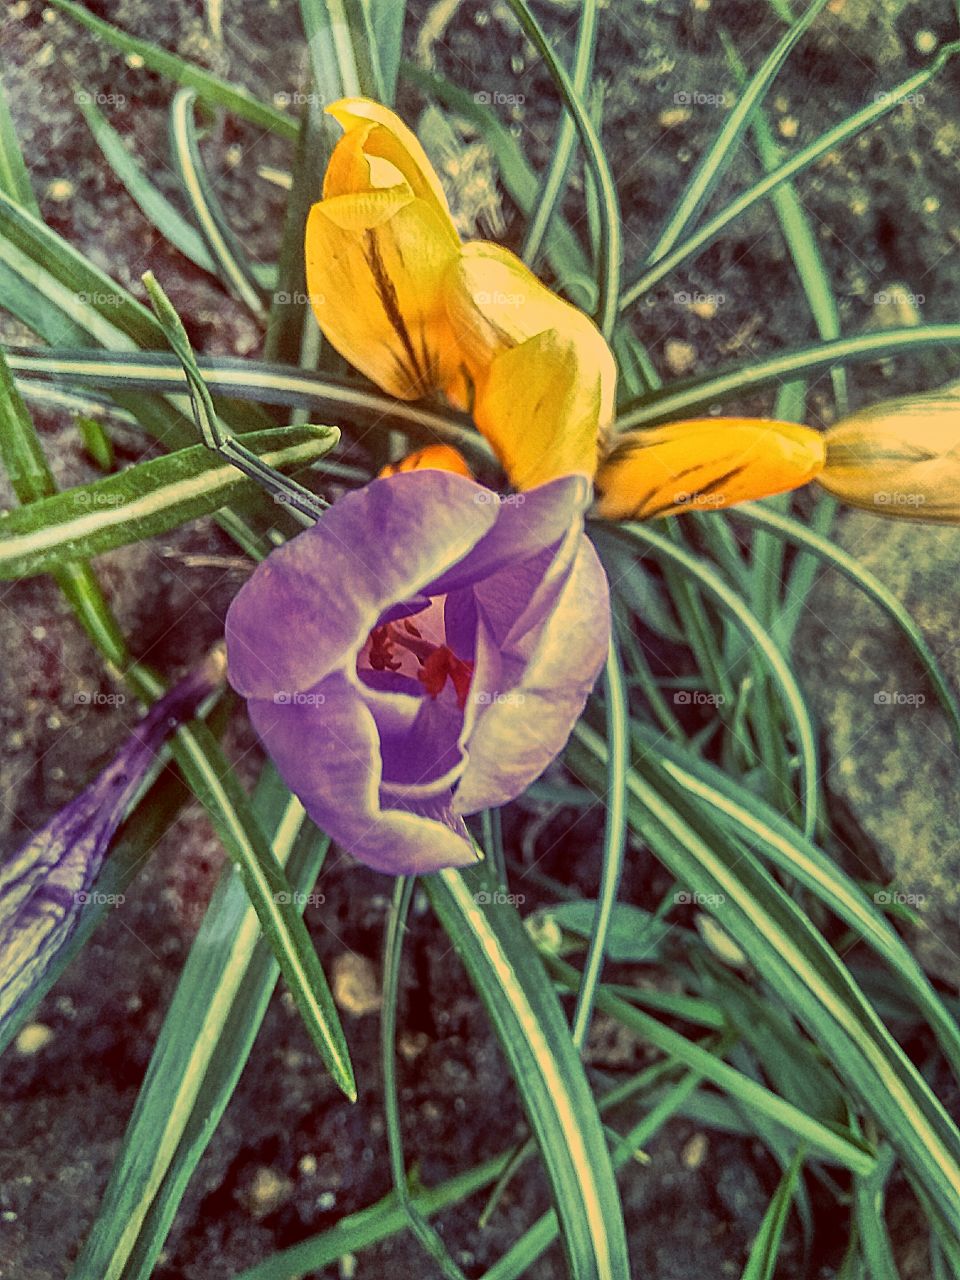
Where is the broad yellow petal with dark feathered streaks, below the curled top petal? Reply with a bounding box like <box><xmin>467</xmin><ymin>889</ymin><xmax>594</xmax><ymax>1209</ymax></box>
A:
<box><xmin>306</xmin><ymin>187</ymin><xmax>463</xmax><ymax>399</ymax></box>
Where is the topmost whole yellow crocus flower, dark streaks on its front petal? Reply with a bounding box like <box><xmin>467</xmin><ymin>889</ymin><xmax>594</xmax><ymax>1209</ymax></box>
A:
<box><xmin>306</xmin><ymin>97</ymin><xmax>466</xmax><ymax>406</ymax></box>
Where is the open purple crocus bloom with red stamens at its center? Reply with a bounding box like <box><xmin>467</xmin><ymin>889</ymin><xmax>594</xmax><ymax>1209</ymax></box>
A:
<box><xmin>227</xmin><ymin>471</ymin><xmax>609</xmax><ymax>874</ymax></box>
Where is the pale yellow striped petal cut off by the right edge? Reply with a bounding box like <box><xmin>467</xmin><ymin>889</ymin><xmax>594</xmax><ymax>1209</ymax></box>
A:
<box><xmin>817</xmin><ymin>396</ymin><xmax>960</xmax><ymax>524</ymax></box>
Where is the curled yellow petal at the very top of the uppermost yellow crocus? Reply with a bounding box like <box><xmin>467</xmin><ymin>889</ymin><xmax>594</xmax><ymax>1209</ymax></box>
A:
<box><xmin>324</xmin><ymin>97</ymin><xmax>456</xmax><ymax>234</ymax></box>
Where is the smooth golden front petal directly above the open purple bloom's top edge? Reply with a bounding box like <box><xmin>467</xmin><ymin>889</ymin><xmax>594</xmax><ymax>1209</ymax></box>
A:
<box><xmin>474</xmin><ymin>329</ymin><xmax>602</xmax><ymax>489</ymax></box>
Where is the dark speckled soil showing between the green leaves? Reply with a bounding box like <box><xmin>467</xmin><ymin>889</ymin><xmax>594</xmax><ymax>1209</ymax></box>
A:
<box><xmin>0</xmin><ymin>0</ymin><xmax>960</xmax><ymax>1280</ymax></box>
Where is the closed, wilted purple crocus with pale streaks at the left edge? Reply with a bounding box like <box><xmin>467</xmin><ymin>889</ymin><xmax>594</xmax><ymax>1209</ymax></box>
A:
<box><xmin>0</xmin><ymin>649</ymin><xmax>224</xmax><ymax>1034</ymax></box>
